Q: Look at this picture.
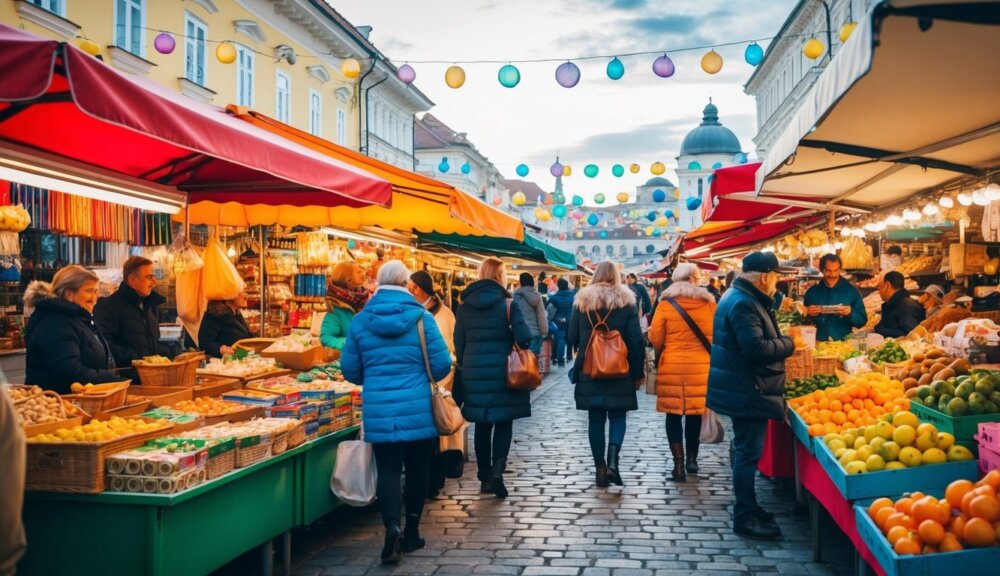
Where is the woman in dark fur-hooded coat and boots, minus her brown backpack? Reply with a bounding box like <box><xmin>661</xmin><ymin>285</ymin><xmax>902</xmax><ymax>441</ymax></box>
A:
<box><xmin>566</xmin><ymin>262</ymin><xmax>645</xmax><ymax>487</ymax></box>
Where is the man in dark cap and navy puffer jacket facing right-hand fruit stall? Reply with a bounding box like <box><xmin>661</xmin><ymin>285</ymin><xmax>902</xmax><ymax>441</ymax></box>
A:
<box><xmin>708</xmin><ymin>252</ymin><xmax>795</xmax><ymax>540</ymax></box>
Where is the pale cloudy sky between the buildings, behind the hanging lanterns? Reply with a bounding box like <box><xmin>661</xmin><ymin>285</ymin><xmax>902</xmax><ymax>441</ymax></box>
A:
<box><xmin>329</xmin><ymin>0</ymin><xmax>795</xmax><ymax>199</ymax></box>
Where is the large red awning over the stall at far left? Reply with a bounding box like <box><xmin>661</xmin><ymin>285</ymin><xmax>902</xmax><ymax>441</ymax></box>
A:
<box><xmin>0</xmin><ymin>24</ymin><xmax>392</xmax><ymax>207</ymax></box>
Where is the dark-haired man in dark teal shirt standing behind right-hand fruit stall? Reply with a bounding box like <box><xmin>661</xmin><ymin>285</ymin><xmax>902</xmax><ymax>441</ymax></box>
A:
<box><xmin>803</xmin><ymin>254</ymin><xmax>868</xmax><ymax>342</ymax></box>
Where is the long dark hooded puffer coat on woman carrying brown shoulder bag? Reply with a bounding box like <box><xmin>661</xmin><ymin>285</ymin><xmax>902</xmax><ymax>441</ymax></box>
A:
<box><xmin>455</xmin><ymin>280</ymin><xmax>531</xmax><ymax>423</ymax></box>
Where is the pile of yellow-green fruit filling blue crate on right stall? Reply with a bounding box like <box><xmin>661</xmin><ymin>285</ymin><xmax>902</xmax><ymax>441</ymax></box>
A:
<box><xmin>823</xmin><ymin>411</ymin><xmax>975</xmax><ymax>474</ymax></box>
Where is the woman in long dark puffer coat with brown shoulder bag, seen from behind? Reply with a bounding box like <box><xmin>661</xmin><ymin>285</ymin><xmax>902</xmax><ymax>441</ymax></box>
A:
<box><xmin>455</xmin><ymin>258</ymin><xmax>531</xmax><ymax>498</ymax></box>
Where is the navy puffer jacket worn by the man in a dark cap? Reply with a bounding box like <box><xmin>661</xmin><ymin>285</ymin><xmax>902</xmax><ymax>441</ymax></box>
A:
<box><xmin>707</xmin><ymin>278</ymin><xmax>795</xmax><ymax>420</ymax></box>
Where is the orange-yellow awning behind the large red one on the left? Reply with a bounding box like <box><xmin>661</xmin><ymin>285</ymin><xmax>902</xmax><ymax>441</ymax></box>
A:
<box><xmin>175</xmin><ymin>105</ymin><xmax>524</xmax><ymax>240</ymax></box>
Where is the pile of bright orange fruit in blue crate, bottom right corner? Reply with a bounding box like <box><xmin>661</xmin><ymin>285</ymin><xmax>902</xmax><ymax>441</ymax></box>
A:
<box><xmin>868</xmin><ymin>470</ymin><xmax>1000</xmax><ymax>556</ymax></box>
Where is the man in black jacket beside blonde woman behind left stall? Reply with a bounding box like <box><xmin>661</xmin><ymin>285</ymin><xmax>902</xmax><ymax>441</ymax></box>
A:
<box><xmin>94</xmin><ymin>256</ymin><xmax>166</xmax><ymax>367</ymax></box>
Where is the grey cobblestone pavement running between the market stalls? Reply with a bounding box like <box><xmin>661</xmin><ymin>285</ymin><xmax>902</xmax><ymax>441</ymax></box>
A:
<box><xmin>293</xmin><ymin>368</ymin><xmax>844</xmax><ymax>576</ymax></box>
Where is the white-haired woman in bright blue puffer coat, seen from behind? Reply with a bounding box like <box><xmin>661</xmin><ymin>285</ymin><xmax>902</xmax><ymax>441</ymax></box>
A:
<box><xmin>340</xmin><ymin>260</ymin><xmax>451</xmax><ymax>564</ymax></box>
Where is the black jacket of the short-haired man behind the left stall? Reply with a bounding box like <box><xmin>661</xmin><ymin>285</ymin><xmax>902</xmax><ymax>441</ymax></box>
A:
<box><xmin>94</xmin><ymin>282</ymin><xmax>167</xmax><ymax>367</ymax></box>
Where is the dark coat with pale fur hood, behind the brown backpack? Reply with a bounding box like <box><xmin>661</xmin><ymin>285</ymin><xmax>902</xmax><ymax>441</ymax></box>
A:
<box><xmin>566</xmin><ymin>284</ymin><xmax>646</xmax><ymax>410</ymax></box>
